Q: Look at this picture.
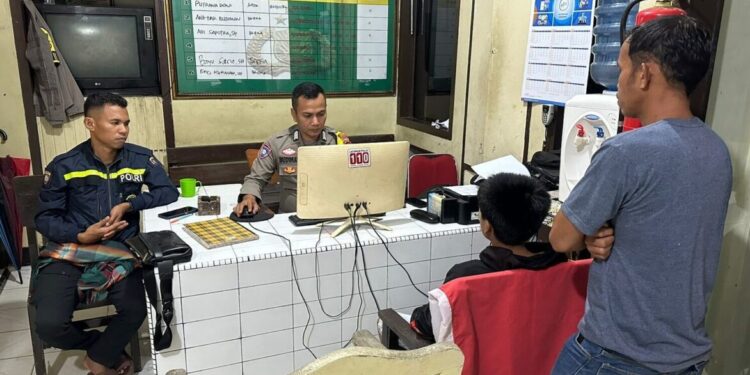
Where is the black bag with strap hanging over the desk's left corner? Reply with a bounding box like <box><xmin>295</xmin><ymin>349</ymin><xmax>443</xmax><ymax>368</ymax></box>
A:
<box><xmin>125</xmin><ymin>230</ymin><xmax>193</xmax><ymax>350</ymax></box>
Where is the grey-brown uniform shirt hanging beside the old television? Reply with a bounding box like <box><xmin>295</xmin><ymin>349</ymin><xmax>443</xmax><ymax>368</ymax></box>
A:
<box><xmin>23</xmin><ymin>0</ymin><xmax>83</xmax><ymax>125</ymax></box>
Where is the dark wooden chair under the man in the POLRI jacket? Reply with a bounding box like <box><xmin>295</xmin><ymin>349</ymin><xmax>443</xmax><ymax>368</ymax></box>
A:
<box><xmin>13</xmin><ymin>176</ymin><xmax>143</xmax><ymax>375</ymax></box>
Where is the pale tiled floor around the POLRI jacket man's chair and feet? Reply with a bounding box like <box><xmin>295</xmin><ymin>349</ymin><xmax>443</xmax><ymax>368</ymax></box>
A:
<box><xmin>0</xmin><ymin>267</ymin><xmax>154</xmax><ymax>375</ymax></box>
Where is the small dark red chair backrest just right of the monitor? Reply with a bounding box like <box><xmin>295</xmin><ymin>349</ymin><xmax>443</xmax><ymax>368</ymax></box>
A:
<box><xmin>406</xmin><ymin>154</ymin><xmax>458</xmax><ymax>198</ymax></box>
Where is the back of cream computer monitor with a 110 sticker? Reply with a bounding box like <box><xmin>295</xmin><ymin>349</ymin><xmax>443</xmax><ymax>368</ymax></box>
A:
<box><xmin>297</xmin><ymin>142</ymin><xmax>409</xmax><ymax>219</ymax></box>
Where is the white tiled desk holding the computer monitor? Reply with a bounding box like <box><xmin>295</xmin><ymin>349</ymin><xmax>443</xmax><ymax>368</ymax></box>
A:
<box><xmin>142</xmin><ymin>184</ymin><xmax>488</xmax><ymax>375</ymax></box>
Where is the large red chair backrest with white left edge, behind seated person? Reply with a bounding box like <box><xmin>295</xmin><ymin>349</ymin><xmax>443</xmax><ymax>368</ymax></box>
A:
<box><xmin>430</xmin><ymin>259</ymin><xmax>591</xmax><ymax>375</ymax></box>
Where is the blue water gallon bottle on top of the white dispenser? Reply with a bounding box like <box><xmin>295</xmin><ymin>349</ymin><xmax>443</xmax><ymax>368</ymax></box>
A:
<box><xmin>591</xmin><ymin>0</ymin><xmax>638</xmax><ymax>91</ymax></box>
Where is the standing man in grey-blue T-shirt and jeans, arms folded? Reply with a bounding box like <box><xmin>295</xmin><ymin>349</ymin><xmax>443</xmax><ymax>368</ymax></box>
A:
<box><xmin>550</xmin><ymin>16</ymin><xmax>732</xmax><ymax>375</ymax></box>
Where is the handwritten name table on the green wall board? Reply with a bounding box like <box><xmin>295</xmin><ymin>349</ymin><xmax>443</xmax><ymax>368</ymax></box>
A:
<box><xmin>183</xmin><ymin>0</ymin><xmax>389</xmax><ymax>80</ymax></box>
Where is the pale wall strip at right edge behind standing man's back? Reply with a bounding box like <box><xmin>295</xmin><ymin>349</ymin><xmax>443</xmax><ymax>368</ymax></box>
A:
<box><xmin>707</xmin><ymin>0</ymin><xmax>750</xmax><ymax>375</ymax></box>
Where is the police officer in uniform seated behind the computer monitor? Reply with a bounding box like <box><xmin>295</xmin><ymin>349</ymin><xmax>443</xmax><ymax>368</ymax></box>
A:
<box><xmin>234</xmin><ymin>82</ymin><xmax>349</xmax><ymax>215</ymax></box>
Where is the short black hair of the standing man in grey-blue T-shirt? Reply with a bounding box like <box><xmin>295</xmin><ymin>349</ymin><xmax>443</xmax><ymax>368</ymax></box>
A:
<box><xmin>628</xmin><ymin>16</ymin><xmax>713</xmax><ymax>95</ymax></box>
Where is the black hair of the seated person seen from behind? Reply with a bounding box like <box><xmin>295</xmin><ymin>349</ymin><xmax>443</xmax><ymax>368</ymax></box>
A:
<box><xmin>477</xmin><ymin>173</ymin><xmax>550</xmax><ymax>246</ymax></box>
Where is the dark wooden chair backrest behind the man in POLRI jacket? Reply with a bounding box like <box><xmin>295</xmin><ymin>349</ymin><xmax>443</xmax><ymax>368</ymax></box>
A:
<box><xmin>13</xmin><ymin>176</ymin><xmax>44</xmax><ymax>265</ymax></box>
